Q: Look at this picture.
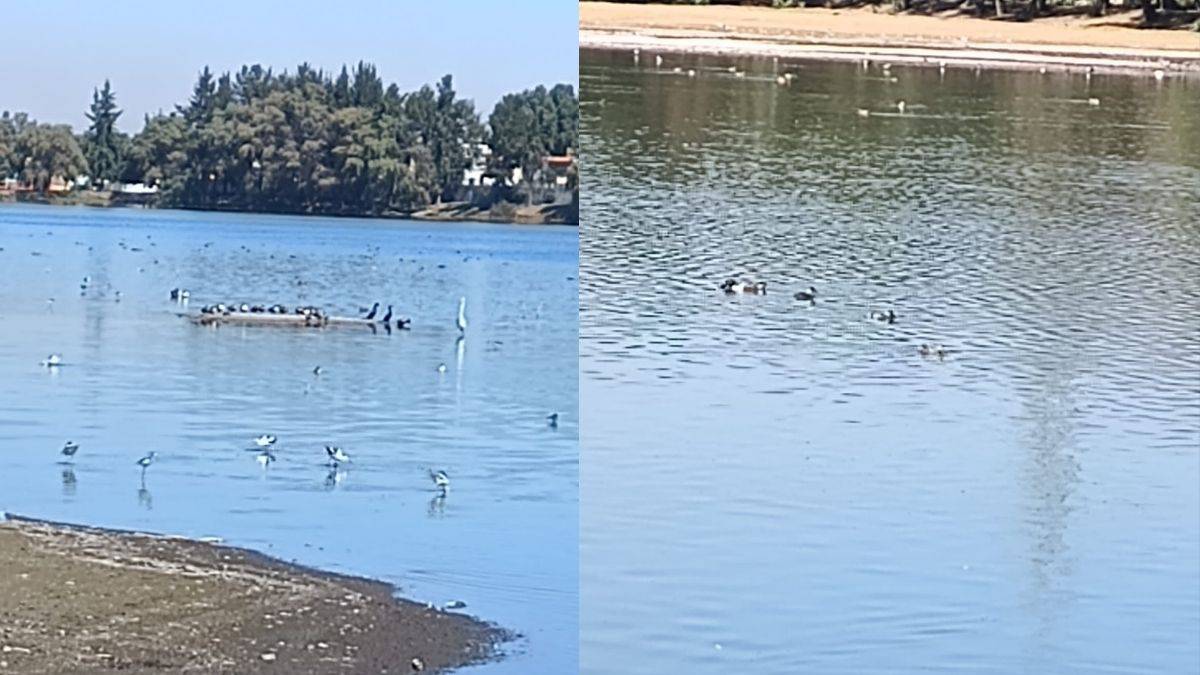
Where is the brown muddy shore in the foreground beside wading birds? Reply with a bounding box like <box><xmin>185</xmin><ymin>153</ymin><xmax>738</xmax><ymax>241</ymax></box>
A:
<box><xmin>0</xmin><ymin>511</ymin><xmax>505</xmax><ymax>674</ymax></box>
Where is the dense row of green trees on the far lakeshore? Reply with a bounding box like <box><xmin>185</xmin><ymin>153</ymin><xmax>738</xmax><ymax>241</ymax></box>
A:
<box><xmin>0</xmin><ymin>62</ymin><xmax>578</xmax><ymax>215</ymax></box>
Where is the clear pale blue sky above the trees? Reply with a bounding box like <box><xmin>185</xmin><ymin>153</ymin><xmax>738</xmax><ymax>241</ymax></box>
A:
<box><xmin>0</xmin><ymin>0</ymin><xmax>578</xmax><ymax>132</ymax></box>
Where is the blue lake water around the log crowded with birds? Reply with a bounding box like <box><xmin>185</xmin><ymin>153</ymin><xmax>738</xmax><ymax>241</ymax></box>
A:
<box><xmin>0</xmin><ymin>205</ymin><xmax>578</xmax><ymax>674</ymax></box>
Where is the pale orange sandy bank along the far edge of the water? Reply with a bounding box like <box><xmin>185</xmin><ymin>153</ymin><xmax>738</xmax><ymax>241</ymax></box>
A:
<box><xmin>580</xmin><ymin>2</ymin><xmax>1200</xmax><ymax>77</ymax></box>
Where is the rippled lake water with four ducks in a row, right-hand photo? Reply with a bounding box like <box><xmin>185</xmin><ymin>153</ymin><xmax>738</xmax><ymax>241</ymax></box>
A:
<box><xmin>581</xmin><ymin>52</ymin><xmax>1200</xmax><ymax>675</ymax></box>
